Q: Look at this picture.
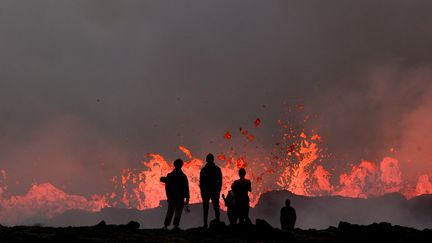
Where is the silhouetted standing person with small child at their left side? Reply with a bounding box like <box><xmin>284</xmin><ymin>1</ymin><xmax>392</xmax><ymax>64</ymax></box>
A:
<box><xmin>232</xmin><ymin>168</ymin><xmax>252</xmax><ymax>224</ymax></box>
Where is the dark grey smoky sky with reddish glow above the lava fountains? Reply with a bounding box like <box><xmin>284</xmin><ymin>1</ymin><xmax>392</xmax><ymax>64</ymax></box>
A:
<box><xmin>0</xmin><ymin>0</ymin><xmax>432</xmax><ymax>194</ymax></box>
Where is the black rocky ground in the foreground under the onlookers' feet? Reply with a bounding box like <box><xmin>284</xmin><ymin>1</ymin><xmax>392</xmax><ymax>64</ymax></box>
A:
<box><xmin>0</xmin><ymin>219</ymin><xmax>432</xmax><ymax>242</ymax></box>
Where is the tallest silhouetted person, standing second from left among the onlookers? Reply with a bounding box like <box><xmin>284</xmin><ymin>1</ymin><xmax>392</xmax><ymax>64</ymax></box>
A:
<box><xmin>200</xmin><ymin>154</ymin><xmax>222</xmax><ymax>228</ymax></box>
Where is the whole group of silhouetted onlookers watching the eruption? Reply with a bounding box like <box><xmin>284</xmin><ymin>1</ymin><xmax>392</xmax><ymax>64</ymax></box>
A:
<box><xmin>160</xmin><ymin>154</ymin><xmax>296</xmax><ymax>230</ymax></box>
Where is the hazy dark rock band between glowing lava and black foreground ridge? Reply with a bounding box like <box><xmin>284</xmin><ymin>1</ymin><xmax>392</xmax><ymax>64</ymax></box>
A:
<box><xmin>40</xmin><ymin>191</ymin><xmax>432</xmax><ymax>229</ymax></box>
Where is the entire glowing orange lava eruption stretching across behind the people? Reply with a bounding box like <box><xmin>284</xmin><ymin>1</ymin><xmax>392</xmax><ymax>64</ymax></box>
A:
<box><xmin>0</xmin><ymin>108</ymin><xmax>432</xmax><ymax>224</ymax></box>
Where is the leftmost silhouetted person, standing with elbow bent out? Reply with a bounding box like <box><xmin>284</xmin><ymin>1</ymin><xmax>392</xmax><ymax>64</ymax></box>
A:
<box><xmin>161</xmin><ymin>159</ymin><xmax>189</xmax><ymax>228</ymax></box>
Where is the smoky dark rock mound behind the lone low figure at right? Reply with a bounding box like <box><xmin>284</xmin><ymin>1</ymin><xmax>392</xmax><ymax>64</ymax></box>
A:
<box><xmin>251</xmin><ymin>191</ymin><xmax>432</xmax><ymax>229</ymax></box>
